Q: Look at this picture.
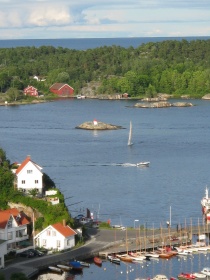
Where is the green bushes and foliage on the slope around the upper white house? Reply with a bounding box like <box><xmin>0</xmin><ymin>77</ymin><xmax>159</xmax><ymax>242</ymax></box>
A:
<box><xmin>0</xmin><ymin>149</ymin><xmax>73</xmax><ymax>230</ymax></box>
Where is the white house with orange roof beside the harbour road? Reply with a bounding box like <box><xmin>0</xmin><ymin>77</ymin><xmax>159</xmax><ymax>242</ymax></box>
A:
<box><xmin>34</xmin><ymin>222</ymin><xmax>77</xmax><ymax>251</ymax></box>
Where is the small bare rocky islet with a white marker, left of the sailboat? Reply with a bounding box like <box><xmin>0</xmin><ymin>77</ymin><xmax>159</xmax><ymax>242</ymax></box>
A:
<box><xmin>75</xmin><ymin>120</ymin><xmax>123</xmax><ymax>130</ymax></box>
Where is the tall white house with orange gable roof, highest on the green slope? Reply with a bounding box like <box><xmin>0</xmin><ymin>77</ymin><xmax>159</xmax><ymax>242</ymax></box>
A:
<box><xmin>15</xmin><ymin>156</ymin><xmax>43</xmax><ymax>194</ymax></box>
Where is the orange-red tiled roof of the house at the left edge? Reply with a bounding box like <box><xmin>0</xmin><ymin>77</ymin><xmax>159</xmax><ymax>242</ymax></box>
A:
<box><xmin>0</xmin><ymin>208</ymin><xmax>30</xmax><ymax>228</ymax></box>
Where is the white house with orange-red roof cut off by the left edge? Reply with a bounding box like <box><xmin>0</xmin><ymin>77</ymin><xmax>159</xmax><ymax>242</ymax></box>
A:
<box><xmin>0</xmin><ymin>208</ymin><xmax>30</xmax><ymax>253</ymax></box>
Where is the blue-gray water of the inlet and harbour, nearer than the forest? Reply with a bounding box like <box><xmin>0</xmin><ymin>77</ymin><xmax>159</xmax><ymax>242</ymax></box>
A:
<box><xmin>0</xmin><ymin>99</ymin><xmax>210</xmax><ymax>280</ymax></box>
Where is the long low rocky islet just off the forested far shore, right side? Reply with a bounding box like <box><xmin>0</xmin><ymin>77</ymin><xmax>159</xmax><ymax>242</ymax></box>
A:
<box><xmin>134</xmin><ymin>101</ymin><xmax>193</xmax><ymax>108</ymax></box>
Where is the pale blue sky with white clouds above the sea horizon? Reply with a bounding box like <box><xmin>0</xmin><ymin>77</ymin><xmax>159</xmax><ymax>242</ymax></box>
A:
<box><xmin>0</xmin><ymin>0</ymin><xmax>210</xmax><ymax>40</ymax></box>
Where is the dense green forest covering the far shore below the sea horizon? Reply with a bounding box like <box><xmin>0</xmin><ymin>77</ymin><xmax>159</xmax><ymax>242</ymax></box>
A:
<box><xmin>0</xmin><ymin>40</ymin><xmax>210</xmax><ymax>98</ymax></box>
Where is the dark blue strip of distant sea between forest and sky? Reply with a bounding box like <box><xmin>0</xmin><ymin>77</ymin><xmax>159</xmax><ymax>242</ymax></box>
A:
<box><xmin>0</xmin><ymin>36</ymin><xmax>210</xmax><ymax>50</ymax></box>
